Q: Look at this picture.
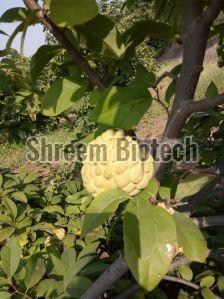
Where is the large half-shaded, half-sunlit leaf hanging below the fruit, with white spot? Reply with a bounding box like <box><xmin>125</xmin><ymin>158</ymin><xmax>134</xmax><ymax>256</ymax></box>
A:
<box><xmin>124</xmin><ymin>196</ymin><xmax>177</xmax><ymax>291</ymax></box>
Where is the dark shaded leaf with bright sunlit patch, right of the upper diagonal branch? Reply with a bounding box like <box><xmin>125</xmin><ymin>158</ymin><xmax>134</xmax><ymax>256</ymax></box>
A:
<box><xmin>75</xmin><ymin>14</ymin><xmax>125</xmax><ymax>59</ymax></box>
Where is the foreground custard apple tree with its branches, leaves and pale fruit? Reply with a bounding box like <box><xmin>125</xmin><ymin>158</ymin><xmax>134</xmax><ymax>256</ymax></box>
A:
<box><xmin>0</xmin><ymin>0</ymin><xmax>224</xmax><ymax>299</ymax></box>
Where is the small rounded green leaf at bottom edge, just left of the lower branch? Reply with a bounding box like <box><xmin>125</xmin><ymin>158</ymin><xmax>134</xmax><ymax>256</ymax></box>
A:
<box><xmin>67</xmin><ymin>276</ymin><xmax>92</xmax><ymax>298</ymax></box>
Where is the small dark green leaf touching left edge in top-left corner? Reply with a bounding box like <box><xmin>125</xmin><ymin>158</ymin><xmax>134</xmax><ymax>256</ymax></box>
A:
<box><xmin>0</xmin><ymin>7</ymin><xmax>27</xmax><ymax>23</ymax></box>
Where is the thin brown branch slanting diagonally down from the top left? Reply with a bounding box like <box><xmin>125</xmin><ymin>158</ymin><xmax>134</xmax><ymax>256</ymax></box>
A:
<box><xmin>23</xmin><ymin>0</ymin><xmax>107</xmax><ymax>89</ymax></box>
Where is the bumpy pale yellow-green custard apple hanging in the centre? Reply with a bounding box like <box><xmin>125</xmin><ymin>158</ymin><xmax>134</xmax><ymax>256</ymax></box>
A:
<box><xmin>81</xmin><ymin>130</ymin><xmax>154</xmax><ymax>197</ymax></box>
